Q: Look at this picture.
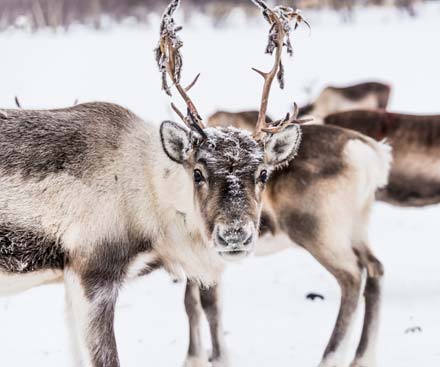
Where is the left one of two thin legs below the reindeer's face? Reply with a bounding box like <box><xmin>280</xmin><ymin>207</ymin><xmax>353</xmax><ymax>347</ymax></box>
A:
<box><xmin>185</xmin><ymin>280</ymin><xmax>209</xmax><ymax>367</ymax></box>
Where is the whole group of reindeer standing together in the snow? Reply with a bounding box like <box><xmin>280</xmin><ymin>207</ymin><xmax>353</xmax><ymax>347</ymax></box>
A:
<box><xmin>0</xmin><ymin>0</ymin><xmax>440</xmax><ymax>367</ymax></box>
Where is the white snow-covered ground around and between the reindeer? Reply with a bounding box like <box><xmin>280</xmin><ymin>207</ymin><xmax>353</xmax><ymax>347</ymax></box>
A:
<box><xmin>0</xmin><ymin>3</ymin><xmax>440</xmax><ymax>367</ymax></box>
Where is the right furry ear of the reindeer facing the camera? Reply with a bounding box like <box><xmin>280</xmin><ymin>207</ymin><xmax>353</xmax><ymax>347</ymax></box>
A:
<box><xmin>264</xmin><ymin>124</ymin><xmax>302</xmax><ymax>168</ymax></box>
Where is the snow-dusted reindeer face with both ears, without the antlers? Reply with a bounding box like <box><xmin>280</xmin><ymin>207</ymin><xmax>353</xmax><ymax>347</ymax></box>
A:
<box><xmin>161</xmin><ymin>121</ymin><xmax>300</xmax><ymax>260</ymax></box>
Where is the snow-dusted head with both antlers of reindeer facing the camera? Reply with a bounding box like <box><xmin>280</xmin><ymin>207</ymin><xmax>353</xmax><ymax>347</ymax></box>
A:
<box><xmin>156</xmin><ymin>0</ymin><xmax>301</xmax><ymax>259</ymax></box>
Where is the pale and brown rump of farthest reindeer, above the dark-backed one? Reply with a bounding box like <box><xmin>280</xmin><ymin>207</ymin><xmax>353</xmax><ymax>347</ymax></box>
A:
<box><xmin>300</xmin><ymin>82</ymin><xmax>391</xmax><ymax>121</ymax></box>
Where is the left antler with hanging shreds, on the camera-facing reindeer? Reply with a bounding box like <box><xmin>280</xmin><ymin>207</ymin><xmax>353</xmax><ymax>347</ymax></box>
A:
<box><xmin>155</xmin><ymin>0</ymin><xmax>206</xmax><ymax>137</ymax></box>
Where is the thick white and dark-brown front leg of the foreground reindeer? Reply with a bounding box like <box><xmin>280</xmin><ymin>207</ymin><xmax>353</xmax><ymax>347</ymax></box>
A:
<box><xmin>64</xmin><ymin>269</ymin><xmax>119</xmax><ymax>367</ymax></box>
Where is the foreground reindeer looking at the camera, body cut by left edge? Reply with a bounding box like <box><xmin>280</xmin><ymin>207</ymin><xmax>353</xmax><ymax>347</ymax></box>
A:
<box><xmin>0</xmin><ymin>0</ymin><xmax>301</xmax><ymax>367</ymax></box>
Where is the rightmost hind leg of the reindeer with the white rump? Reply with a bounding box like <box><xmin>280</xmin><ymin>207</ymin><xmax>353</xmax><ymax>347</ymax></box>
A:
<box><xmin>351</xmin><ymin>248</ymin><xmax>383</xmax><ymax>367</ymax></box>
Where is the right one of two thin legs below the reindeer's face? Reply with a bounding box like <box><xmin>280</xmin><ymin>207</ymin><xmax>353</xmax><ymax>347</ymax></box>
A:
<box><xmin>200</xmin><ymin>284</ymin><xmax>229</xmax><ymax>367</ymax></box>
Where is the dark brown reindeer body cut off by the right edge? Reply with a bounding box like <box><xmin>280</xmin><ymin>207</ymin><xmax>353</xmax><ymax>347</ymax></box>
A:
<box><xmin>324</xmin><ymin>110</ymin><xmax>440</xmax><ymax>206</ymax></box>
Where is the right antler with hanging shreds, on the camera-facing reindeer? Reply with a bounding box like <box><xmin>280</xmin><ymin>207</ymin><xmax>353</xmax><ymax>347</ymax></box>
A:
<box><xmin>252</xmin><ymin>0</ymin><xmax>310</xmax><ymax>140</ymax></box>
